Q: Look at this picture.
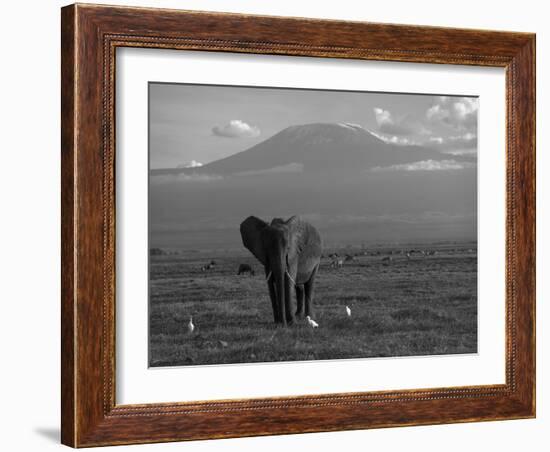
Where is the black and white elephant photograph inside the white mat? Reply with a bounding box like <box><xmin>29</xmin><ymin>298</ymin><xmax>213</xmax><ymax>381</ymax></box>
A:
<box><xmin>148</xmin><ymin>82</ymin><xmax>479</xmax><ymax>367</ymax></box>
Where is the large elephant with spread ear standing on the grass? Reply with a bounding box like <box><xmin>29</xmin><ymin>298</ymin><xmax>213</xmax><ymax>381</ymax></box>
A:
<box><xmin>240</xmin><ymin>216</ymin><xmax>322</xmax><ymax>326</ymax></box>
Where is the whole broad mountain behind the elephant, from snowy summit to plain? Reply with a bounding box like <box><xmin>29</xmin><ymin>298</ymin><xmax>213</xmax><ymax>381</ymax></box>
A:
<box><xmin>149</xmin><ymin>123</ymin><xmax>477</xmax><ymax>250</ymax></box>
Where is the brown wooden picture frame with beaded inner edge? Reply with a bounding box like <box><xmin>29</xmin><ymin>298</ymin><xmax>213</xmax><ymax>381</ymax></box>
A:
<box><xmin>61</xmin><ymin>4</ymin><xmax>535</xmax><ymax>447</ymax></box>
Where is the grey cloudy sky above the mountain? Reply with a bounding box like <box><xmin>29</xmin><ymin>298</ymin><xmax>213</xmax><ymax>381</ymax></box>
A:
<box><xmin>149</xmin><ymin>83</ymin><xmax>478</xmax><ymax>169</ymax></box>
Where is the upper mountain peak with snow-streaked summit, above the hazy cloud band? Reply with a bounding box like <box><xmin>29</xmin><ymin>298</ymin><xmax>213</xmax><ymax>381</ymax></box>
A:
<box><xmin>151</xmin><ymin>123</ymin><xmax>470</xmax><ymax>175</ymax></box>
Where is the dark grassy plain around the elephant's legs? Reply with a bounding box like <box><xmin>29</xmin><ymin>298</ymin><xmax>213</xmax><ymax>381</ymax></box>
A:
<box><xmin>149</xmin><ymin>243</ymin><xmax>477</xmax><ymax>366</ymax></box>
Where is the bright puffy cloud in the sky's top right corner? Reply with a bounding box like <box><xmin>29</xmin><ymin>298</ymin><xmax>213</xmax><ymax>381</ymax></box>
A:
<box><xmin>426</xmin><ymin>96</ymin><xmax>479</xmax><ymax>129</ymax></box>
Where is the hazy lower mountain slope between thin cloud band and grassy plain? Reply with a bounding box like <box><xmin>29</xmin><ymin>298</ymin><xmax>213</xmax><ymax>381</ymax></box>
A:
<box><xmin>149</xmin><ymin>168</ymin><xmax>476</xmax><ymax>249</ymax></box>
